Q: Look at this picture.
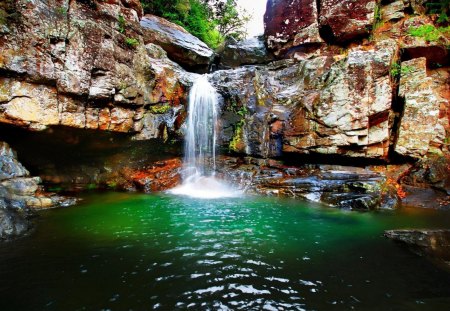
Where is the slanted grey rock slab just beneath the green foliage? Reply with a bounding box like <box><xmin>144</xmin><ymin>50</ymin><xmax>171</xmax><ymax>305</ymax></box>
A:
<box><xmin>140</xmin><ymin>15</ymin><xmax>214</xmax><ymax>72</ymax></box>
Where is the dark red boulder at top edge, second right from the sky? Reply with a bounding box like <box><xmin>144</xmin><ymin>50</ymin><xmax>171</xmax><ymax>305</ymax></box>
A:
<box><xmin>319</xmin><ymin>0</ymin><xmax>377</xmax><ymax>42</ymax></box>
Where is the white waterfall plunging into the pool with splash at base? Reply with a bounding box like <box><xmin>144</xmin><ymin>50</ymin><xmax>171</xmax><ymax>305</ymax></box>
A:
<box><xmin>171</xmin><ymin>75</ymin><xmax>240</xmax><ymax>198</ymax></box>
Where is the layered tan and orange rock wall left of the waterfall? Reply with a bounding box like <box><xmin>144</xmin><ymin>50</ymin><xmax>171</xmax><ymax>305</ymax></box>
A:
<box><xmin>0</xmin><ymin>0</ymin><xmax>191</xmax><ymax>138</ymax></box>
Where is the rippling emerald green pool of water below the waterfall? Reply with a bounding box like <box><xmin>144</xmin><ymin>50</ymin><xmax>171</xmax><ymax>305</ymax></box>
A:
<box><xmin>0</xmin><ymin>193</ymin><xmax>450</xmax><ymax>311</ymax></box>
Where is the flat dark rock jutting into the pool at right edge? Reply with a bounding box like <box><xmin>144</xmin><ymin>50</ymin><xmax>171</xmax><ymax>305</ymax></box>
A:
<box><xmin>384</xmin><ymin>229</ymin><xmax>450</xmax><ymax>269</ymax></box>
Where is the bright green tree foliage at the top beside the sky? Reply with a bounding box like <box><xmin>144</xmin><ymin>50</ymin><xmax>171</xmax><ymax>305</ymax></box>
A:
<box><xmin>141</xmin><ymin>0</ymin><xmax>250</xmax><ymax>48</ymax></box>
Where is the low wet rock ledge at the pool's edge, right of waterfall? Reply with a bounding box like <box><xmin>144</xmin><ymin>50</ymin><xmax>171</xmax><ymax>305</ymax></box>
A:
<box><xmin>218</xmin><ymin>157</ymin><xmax>400</xmax><ymax>211</ymax></box>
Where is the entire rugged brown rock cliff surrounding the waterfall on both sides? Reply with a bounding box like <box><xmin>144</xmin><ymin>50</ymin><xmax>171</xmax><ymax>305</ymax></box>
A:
<box><xmin>0</xmin><ymin>0</ymin><xmax>450</xmax><ymax>212</ymax></box>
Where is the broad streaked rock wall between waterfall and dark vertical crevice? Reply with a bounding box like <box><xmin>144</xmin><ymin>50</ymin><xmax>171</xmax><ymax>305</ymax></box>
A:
<box><xmin>212</xmin><ymin>40</ymin><xmax>398</xmax><ymax>158</ymax></box>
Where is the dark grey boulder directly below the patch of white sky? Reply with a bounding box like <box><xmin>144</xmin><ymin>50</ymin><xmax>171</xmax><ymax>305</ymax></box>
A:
<box><xmin>219</xmin><ymin>36</ymin><xmax>274</xmax><ymax>68</ymax></box>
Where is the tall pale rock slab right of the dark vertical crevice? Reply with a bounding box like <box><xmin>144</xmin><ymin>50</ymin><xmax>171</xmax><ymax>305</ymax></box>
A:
<box><xmin>395</xmin><ymin>58</ymin><xmax>439</xmax><ymax>158</ymax></box>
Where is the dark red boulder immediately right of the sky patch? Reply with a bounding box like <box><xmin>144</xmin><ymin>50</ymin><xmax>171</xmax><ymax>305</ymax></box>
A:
<box><xmin>264</xmin><ymin>0</ymin><xmax>323</xmax><ymax>57</ymax></box>
